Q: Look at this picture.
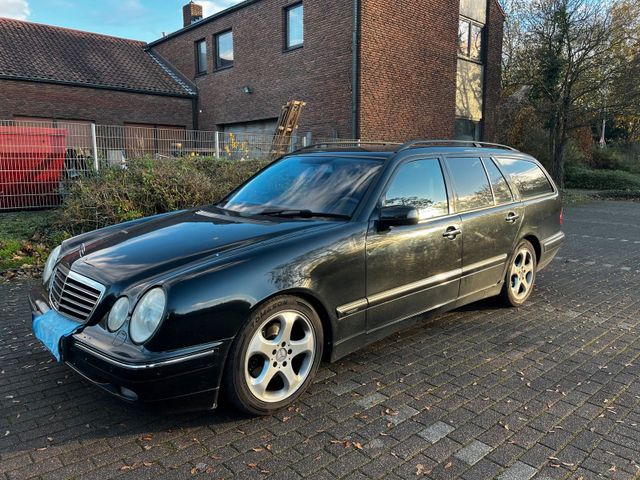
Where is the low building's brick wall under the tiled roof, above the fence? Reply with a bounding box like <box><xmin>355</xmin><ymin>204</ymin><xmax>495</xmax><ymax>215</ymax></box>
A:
<box><xmin>0</xmin><ymin>80</ymin><xmax>192</xmax><ymax>128</ymax></box>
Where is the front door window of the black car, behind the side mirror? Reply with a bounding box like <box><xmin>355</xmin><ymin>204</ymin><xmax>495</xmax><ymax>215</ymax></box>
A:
<box><xmin>382</xmin><ymin>159</ymin><xmax>449</xmax><ymax>220</ymax></box>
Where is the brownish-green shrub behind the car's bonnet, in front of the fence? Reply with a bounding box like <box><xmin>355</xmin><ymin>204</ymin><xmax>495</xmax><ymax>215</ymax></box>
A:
<box><xmin>58</xmin><ymin>157</ymin><xmax>266</xmax><ymax>235</ymax></box>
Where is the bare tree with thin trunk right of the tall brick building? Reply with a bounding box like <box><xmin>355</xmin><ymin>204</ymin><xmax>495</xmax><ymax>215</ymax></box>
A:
<box><xmin>505</xmin><ymin>0</ymin><xmax>640</xmax><ymax>186</ymax></box>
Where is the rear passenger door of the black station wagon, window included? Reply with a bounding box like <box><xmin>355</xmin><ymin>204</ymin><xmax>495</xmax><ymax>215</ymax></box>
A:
<box><xmin>447</xmin><ymin>155</ymin><xmax>523</xmax><ymax>297</ymax></box>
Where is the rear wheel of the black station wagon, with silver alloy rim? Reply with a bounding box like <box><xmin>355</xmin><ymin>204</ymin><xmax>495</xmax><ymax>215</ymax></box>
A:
<box><xmin>500</xmin><ymin>240</ymin><xmax>538</xmax><ymax>307</ymax></box>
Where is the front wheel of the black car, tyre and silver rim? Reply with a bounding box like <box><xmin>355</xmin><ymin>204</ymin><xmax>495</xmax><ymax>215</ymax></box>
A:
<box><xmin>223</xmin><ymin>295</ymin><xmax>324</xmax><ymax>415</ymax></box>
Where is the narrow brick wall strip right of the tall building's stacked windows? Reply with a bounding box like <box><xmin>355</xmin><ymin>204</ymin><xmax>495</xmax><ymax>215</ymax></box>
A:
<box><xmin>483</xmin><ymin>0</ymin><xmax>504</xmax><ymax>142</ymax></box>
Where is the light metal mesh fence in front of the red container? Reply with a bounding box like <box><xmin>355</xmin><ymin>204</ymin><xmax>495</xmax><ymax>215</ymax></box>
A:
<box><xmin>0</xmin><ymin>119</ymin><xmax>368</xmax><ymax>211</ymax></box>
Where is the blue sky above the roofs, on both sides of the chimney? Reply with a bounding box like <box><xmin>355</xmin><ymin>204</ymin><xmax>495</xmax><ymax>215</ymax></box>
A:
<box><xmin>0</xmin><ymin>0</ymin><xmax>241</xmax><ymax>42</ymax></box>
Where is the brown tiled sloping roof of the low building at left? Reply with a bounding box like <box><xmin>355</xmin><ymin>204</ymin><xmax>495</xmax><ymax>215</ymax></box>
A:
<box><xmin>0</xmin><ymin>18</ymin><xmax>196</xmax><ymax>97</ymax></box>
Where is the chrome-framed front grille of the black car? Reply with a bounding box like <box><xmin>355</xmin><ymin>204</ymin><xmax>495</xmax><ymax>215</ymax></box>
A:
<box><xmin>49</xmin><ymin>265</ymin><xmax>105</xmax><ymax>322</ymax></box>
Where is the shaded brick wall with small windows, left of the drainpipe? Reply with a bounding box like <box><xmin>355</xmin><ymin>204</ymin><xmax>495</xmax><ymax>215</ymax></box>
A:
<box><xmin>154</xmin><ymin>0</ymin><xmax>353</xmax><ymax>137</ymax></box>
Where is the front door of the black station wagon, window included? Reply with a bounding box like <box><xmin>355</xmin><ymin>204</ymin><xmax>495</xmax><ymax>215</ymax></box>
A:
<box><xmin>366</xmin><ymin>158</ymin><xmax>462</xmax><ymax>332</ymax></box>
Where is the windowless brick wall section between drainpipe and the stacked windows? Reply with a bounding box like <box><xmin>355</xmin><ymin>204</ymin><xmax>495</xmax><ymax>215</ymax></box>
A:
<box><xmin>360</xmin><ymin>0</ymin><xmax>459</xmax><ymax>141</ymax></box>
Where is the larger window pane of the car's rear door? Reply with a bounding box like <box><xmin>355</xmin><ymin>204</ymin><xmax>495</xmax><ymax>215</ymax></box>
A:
<box><xmin>447</xmin><ymin>157</ymin><xmax>493</xmax><ymax>212</ymax></box>
